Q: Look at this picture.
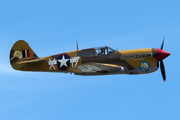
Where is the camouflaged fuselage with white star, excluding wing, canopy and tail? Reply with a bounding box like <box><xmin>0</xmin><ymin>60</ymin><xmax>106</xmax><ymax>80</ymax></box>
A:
<box><xmin>16</xmin><ymin>48</ymin><xmax>158</xmax><ymax>75</ymax></box>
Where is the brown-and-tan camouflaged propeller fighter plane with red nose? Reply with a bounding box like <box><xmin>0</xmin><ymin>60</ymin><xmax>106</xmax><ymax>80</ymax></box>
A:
<box><xmin>10</xmin><ymin>40</ymin><xmax>170</xmax><ymax>81</ymax></box>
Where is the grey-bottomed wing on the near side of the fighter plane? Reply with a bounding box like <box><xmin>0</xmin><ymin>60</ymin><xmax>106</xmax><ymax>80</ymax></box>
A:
<box><xmin>77</xmin><ymin>62</ymin><xmax>124</xmax><ymax>75</ymax></box>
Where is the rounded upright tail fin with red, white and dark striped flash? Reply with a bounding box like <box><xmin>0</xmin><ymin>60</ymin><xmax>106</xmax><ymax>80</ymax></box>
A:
<box><xmin>10</xmin><ymin>40</ymin><xmax>39</xmax><ymax>70</ymax></box>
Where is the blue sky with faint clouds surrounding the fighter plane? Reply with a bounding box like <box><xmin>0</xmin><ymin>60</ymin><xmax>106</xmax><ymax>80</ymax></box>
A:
<box><xmin>0</xmin><ymin>0</ymin><xmax>180</xmax><ymax>120</ymax></box>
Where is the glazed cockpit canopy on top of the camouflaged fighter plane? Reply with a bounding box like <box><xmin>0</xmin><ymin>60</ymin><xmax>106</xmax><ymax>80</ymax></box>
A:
<box><xmin>77</xmin><ymin>46</ymin><xmax>116</xmax><ymax>57</ymax></box>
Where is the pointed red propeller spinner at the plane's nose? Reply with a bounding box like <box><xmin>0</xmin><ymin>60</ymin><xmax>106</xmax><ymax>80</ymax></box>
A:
<box><xmin>156</xmin><ymin>49</ymin><xmax>170</xmax><ymax>61</ymax></box>
